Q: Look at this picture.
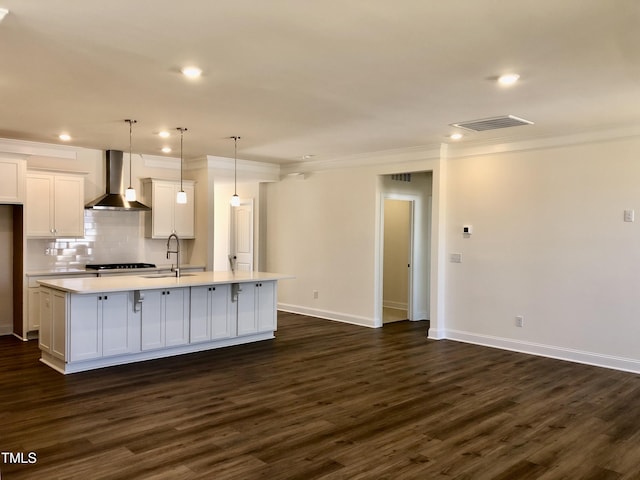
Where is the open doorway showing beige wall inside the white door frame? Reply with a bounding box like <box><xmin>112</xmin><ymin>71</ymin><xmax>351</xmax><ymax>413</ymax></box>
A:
<box><xmin>382</xmin><ymin>198</ymin><xmax>414</xmax><ymax>324</ymax></box>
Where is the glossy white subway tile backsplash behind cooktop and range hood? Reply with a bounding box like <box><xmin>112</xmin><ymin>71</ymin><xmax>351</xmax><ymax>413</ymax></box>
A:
<box><xmin>26</xmin><ymin>210</ymin><xmax>180</xmax><ymax>271</ymax></box>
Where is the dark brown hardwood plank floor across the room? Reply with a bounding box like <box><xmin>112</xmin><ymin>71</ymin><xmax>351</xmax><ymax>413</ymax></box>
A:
<box><xmin>0</xmin><ymin>313</ymin><xmax>640</xmax><ymax>480</ymax></box>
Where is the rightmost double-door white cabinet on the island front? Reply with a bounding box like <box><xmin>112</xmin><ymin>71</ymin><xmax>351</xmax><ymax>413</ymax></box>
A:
<box><xmin>237</xmin><ymin>281</ymin><xmax>277</xmax><ymax>335</ymax></box>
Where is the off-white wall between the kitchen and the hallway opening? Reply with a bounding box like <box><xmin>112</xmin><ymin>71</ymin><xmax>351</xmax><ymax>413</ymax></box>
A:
<box><xmin>266</xmin><ymin>159</ymin><xmax>439</xmax><ymax>327</ymax></box>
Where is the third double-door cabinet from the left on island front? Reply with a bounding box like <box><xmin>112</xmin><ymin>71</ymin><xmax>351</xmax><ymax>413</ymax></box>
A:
<box><xmin>189</xmin><ymin>284</ymin><xmax>235</xmax><ymax>343</ymax></box>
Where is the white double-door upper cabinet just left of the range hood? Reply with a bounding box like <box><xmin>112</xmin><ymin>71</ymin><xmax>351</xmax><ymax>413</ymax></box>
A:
<box><xmin>26</xmin><ymin>172</ymin><xmax>84</xmax><ymax>238</ymax></box>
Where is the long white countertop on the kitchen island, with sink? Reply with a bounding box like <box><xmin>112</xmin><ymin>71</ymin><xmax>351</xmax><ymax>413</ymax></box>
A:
<box><xmin>38</xmin><ymin>272</ymin><xmax>294</xmax><ymax>294</ymax></box>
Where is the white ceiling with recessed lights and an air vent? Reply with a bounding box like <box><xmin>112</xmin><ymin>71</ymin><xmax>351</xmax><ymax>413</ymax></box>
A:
<box><xmin>0</xmin><ymin>0</ymin><xmax>640</xmax><ymax>164</ymax></box>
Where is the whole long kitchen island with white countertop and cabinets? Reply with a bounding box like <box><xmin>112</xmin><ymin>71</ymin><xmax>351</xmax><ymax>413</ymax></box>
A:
<box><xmin>38</xmin><ymin>272</ymin><xmax>292</xmax><ymax>373</ymax></box>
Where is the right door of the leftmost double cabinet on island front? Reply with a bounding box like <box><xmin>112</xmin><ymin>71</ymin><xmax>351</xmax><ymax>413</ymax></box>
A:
<box><xmin>102</xmin><ymin>292</ymin><xmax>131</xmax><ymax>357</ymax></box>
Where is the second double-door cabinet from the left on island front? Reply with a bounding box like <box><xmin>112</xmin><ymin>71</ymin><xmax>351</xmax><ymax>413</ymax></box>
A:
<box><xmin>140</xmin><ymin>288</ymin><xmax>189</xmax><ymax>350</ymax></box>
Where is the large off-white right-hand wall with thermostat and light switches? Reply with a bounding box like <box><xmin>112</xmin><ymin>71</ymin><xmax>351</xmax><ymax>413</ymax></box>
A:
<box><xmin>445</xmin><ymin>138</ymin><xmax>640</xmax><ymax>370</ymax></box>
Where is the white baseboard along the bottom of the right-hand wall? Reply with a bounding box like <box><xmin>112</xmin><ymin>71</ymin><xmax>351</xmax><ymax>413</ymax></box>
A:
<box><xmin>448</xmin><ymin>329</ymin><xmax>640</xmax><ymax>373</ymax></box>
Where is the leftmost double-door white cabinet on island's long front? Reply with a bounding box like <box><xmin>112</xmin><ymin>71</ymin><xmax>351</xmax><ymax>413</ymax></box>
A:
<box><xmin>68</xmin><ymin>292</ymin><xmax>135</xmax><ymax>362</ymax></box>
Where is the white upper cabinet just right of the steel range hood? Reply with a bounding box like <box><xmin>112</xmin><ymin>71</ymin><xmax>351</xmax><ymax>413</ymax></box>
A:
<box><xmin>142</xmin><ymin>178</ymin><xmax>195</xmax><ymax>238</ymax></box>
